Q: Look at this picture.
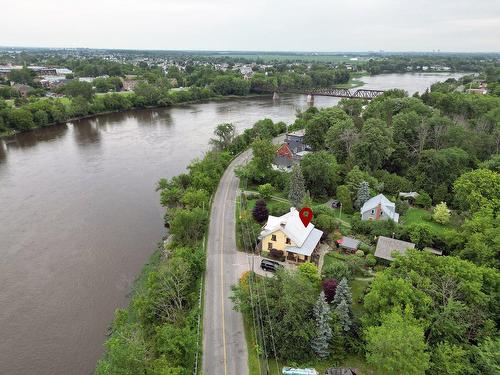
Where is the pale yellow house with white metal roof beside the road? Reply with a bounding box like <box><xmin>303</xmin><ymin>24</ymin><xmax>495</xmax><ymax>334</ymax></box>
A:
<box><xmin>259</xmin><ymin>207</ymin><xmax>323</xmax><ymax>262</ymax></box>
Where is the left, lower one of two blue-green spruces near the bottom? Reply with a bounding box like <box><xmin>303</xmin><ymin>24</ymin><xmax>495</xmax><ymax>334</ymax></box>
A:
<box><xmin>311</xmin><ymin>291</ymin><xmax>332</xmax><ymax>358</ymax></box>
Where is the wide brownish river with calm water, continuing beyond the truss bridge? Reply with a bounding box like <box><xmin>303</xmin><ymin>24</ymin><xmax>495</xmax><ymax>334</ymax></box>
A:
<box><xmin>0</xmin><ymin>74</ymin><xmax>456</xmax><ymax>375</ymax></box>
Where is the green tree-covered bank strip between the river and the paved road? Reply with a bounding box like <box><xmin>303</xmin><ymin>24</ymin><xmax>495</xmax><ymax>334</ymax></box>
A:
<box><xmin>96</xmin><ymin>117</ymin><xmax>284</xmax><ymax>375</ymax></box>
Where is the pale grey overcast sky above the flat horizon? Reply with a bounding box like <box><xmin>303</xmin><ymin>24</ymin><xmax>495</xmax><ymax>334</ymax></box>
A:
<box><xmin>0</xmin><ymin>0</ymin><xmax>500</xmax><ymax>52</ymax></box>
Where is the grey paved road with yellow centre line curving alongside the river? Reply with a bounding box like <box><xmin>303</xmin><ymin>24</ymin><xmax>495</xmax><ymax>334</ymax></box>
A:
<box><xmin>203</xmin><ymin>150</ymin><xmax>251</xmax><ymax>375</ymax></box>
